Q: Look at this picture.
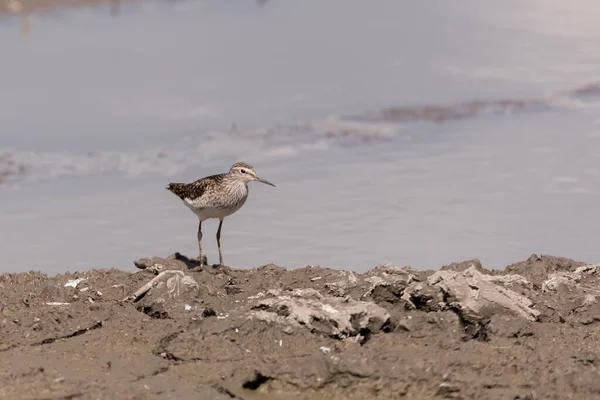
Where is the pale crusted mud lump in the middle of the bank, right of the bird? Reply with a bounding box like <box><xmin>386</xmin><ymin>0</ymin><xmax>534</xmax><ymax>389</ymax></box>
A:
<box><xmin>248</xmin><ymin>289</ymin><xmax>390</xmax><ymax>339</ymax></box>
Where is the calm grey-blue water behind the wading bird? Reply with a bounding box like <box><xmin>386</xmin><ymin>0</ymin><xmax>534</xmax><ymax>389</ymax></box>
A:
<box><xmin>0</xmin><ymin>0</ymin><xmax>600</xmax><ymax>274</ymax></box>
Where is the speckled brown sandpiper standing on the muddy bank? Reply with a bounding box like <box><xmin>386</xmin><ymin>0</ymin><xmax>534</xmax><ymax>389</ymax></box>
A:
<box><xmin>166</xmin><ymin>162</ymin><xmax>275</xmax><ymax>266</ymax></box>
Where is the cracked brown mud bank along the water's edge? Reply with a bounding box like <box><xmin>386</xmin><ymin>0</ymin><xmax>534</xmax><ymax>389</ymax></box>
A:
<box><xmin>0</xmin><ymin>254</ymin><xmax>600</xmax><ymax>399</ymax></box>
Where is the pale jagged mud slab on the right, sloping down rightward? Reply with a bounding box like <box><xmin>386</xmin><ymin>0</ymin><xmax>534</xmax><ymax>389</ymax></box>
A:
<box><xmin>427</xmin><ymin>267</ymin><xmax>540</xmax><ymax>322</ymax></box>
